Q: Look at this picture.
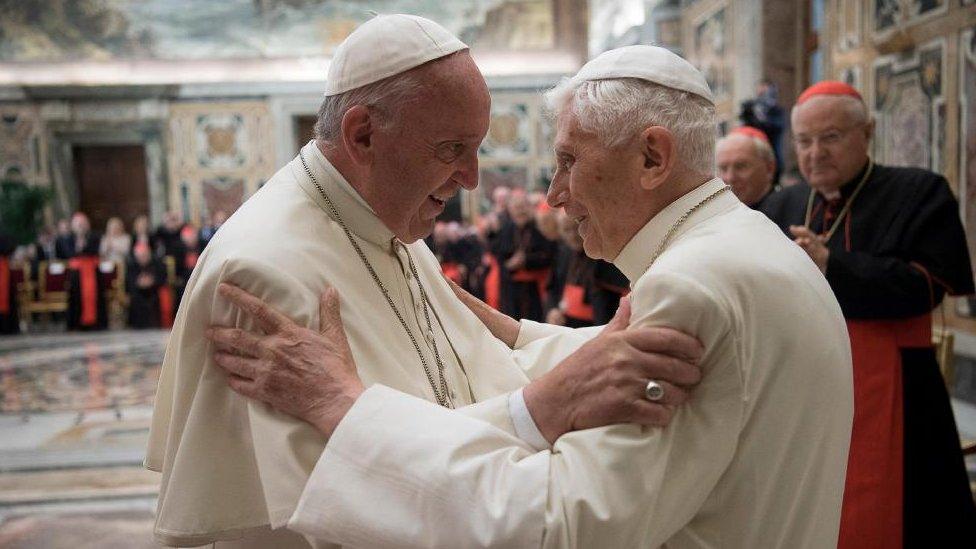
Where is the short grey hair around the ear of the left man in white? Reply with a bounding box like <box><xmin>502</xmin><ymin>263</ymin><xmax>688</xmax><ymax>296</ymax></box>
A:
<box><xmin>314</xmin><ymin>71</ymin><xmax>423</xmax><ymax>145</ymax></box>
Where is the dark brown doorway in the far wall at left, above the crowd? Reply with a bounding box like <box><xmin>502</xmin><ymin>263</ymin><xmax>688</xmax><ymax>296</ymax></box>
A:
<box><xmin>72</xmin><ymin>145</ymin><xmax>149</xmax><ymax>232</ymax></box>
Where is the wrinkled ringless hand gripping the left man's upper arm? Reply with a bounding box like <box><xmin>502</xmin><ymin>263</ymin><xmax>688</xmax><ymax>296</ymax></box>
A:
<box><xmin>207</xmin><ymin>283</ymin><xmax>364</xmax><ymax>436</ymax></box>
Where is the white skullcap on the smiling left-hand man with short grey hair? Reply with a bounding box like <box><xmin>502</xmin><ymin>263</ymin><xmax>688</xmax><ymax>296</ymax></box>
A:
<box><xmin>325</xmin><ymin>14</ymin><xmax>468</xmax><ymax>97</ymax></box>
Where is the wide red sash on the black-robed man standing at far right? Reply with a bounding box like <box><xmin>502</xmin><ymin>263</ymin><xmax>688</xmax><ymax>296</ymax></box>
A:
<box><xmin>837</xmin><ymin>314</ymin><xmax>932</xmax><ymax>549</ymax></box>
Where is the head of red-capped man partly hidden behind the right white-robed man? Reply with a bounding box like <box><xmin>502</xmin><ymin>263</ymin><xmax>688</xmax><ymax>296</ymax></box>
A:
<box><xmin>715</xmin><ymin>126</ymin><xmax>779</xmax><ymax>210</ymax></box>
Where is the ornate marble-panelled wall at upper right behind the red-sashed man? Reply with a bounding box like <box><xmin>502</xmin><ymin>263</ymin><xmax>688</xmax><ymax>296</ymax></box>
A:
<box><xmin>825</xmin><ymin>0</ymin><xmax>976</xmax><ymax>324</ymax></box>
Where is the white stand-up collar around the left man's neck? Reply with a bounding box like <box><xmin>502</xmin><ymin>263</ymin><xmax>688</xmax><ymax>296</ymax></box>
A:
<box><xmin>297</xmin><ymin>140</ymin><xmax>394</xmax><ymax>249</ymax></box>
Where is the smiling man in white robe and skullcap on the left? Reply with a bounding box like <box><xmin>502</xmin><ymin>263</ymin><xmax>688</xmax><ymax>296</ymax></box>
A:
<box><xmin>146</xmin><ymin>15</ymin><xmax>701</xmax><ymax>549</ymax></box>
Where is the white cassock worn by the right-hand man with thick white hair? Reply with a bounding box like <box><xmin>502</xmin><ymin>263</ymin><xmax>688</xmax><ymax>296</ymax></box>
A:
<box><xmin>290</xmin><ymin>179</ymin><xmax>853</xmax><ymax>549</ymax></box>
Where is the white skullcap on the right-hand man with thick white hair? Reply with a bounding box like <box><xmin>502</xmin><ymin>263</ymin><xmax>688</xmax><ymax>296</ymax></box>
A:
<box><xmin>573</xmin><ymin>45</ymin><xmax>715</xmax><ymax>105</ymax></box>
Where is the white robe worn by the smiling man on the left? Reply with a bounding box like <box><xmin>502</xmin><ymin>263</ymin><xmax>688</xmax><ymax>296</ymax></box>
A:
<box><xmin>146</xmin><ymin>143</ymin><xmax>545</xmax><ymax>549</ymax></box>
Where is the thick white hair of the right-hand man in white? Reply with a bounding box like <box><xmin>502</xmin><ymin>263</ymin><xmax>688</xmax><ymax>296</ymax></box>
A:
<box><xmin>545</xmin><ymin>78</ymin><xmax>718</xmax><ymax>174</ymax></box>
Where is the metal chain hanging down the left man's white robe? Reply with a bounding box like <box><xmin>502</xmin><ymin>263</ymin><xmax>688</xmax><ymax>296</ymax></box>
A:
<box><xmin>298</xmin><ymin>152</ymin><xmax>454</xmax><ymax>408</ymax></box>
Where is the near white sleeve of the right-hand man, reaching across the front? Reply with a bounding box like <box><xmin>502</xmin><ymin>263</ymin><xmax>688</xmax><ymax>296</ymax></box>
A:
<box><xmin>290</xmin><ymin>274</ymin><xmax>744</xmax><ymax>548</ymax></box>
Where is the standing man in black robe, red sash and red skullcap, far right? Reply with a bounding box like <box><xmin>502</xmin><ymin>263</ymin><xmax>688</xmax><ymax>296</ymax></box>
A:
<box><xmin>763</xmin><ymin>80</ymin><xmax>976</xmax><ymax>549</ymax></box>
